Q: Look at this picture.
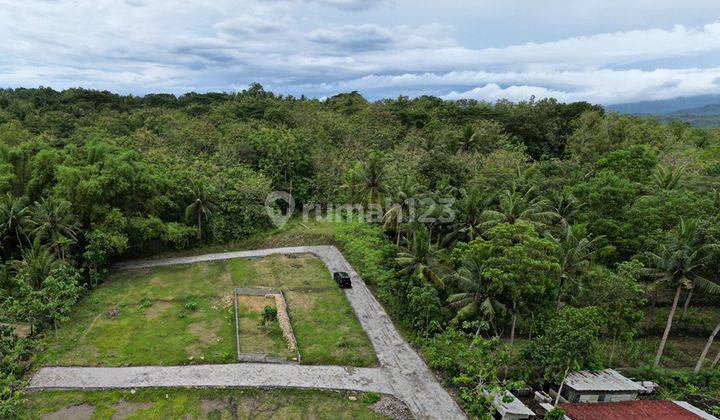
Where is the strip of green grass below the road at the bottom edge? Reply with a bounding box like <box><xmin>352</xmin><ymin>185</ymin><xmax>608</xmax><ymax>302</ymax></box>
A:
<box><xmin>21</xmin><ymin>389</ymin><xmax>385</xmax><ymax>419</ymax></box>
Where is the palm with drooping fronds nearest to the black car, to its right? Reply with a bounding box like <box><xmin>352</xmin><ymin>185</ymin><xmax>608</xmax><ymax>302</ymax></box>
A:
<box><xmin>395</xmin><ymin>224</ymin><xmax>444</xmax><ymax>288</ymax></box>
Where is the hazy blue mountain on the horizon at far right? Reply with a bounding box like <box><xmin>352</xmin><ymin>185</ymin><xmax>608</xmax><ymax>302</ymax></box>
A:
<box><xmin>605</xmin><ymin>95</ymin><xmax>720</xmax><ymax>128</ymax></box>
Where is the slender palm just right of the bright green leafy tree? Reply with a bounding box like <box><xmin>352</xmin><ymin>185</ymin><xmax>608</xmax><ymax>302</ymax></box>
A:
<box><xmin>555</xmin><ymin>224</ymin><xmax>602</xmax><ymax>309</ymax></box>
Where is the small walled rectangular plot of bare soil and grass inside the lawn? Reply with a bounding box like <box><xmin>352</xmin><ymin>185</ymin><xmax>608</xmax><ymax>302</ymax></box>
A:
<box><xmin>237</xmin><ymin>295</ymin><xmax>295</xmax><ymax>360</ymax></box>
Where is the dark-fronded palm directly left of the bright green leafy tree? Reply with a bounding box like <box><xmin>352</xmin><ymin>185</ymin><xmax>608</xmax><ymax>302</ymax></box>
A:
<box><xmin>447</xmin><ymin>249</ymin><xmax>505</xmax><ymax>349</ymax></box>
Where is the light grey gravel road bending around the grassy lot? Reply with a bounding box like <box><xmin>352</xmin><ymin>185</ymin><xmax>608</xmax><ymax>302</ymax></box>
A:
<box><xmin>28</xmin><ymin>246</ymin><xmax>466</xmax><ymax>420</ymax></box>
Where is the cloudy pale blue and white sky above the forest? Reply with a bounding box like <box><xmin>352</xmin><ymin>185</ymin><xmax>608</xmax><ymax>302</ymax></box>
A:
<box><xmin>0</xmin><ymin>0</ymin><xmax>720</xmax><ymax>105</ymax></box>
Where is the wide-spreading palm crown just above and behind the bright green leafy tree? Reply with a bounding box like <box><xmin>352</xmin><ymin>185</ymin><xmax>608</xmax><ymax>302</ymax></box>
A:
<box><xmin>483</xmin><ymin>187</ymin><xmax>557</xmax><ymax>227</ymax></box>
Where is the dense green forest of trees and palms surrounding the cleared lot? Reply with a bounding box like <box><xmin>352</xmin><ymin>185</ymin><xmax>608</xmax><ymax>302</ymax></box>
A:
<box><xmin>0</xmin><ymin>85</ymin><xmax>720</xmax><ymax>418</ymax></box>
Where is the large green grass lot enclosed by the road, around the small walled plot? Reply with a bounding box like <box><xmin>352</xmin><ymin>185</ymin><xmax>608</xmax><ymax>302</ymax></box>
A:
<box><xmin>41</xmin><ymin>255</ymin><xmax>376</xmax><ymax>366</ymax></box>
